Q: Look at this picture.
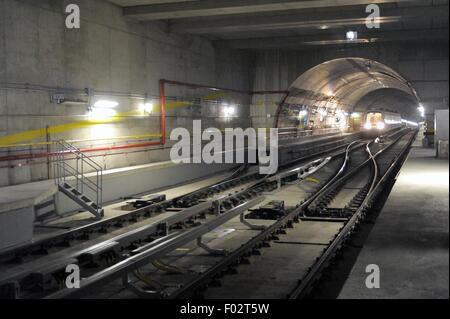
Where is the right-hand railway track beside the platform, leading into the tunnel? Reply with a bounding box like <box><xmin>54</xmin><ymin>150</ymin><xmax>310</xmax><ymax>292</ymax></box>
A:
<box><xmin>168</xmin><ymin>133</ymin><xmax>414</xmax><ymax>298</ymax></box>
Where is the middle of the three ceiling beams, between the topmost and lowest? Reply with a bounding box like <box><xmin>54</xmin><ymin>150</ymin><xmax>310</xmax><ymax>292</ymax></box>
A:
<box><xmin>170</xmin><ymin>5</ymin><xmax>449</xmax><ymax>34</ymax></box>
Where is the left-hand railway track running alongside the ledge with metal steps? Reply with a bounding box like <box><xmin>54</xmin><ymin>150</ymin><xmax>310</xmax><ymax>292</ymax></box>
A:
<box><xmin>0</xmin><ymin>132</ymin><xmax>358</xmax><ymax>298</ymax></box>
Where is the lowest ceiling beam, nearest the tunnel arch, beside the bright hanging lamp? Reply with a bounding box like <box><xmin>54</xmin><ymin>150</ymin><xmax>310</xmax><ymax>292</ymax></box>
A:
<box><xmin>214</xmin><ymin>28</ymin><xmax>448</xmax><ymax>49</ymax></box>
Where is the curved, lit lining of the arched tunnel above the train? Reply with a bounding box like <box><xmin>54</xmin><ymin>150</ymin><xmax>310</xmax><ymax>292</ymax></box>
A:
<box><xmin>275</xmin><ymin>57</ymin><xmax>420</xmax><ymax>128</ymax></box>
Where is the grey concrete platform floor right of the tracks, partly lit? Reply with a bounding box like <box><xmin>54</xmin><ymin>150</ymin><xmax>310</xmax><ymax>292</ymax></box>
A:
<box><xmin>339</xmin><ymin>147</ymin><xmax>449</xmax><ymax>299</ymax></box>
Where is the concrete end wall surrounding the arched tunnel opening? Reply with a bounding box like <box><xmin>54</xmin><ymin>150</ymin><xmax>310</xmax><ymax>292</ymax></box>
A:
<box><xmin>251</xmin><ymin>42</ymin><xmax>449</xmax><ymax>126</ymax></box>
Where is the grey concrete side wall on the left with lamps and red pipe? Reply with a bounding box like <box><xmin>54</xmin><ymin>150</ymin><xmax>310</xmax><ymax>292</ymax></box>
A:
<box><xmin>0</xmin><ymin>0</ymin><xmax>250</xmax><ymax>186</ymax></box>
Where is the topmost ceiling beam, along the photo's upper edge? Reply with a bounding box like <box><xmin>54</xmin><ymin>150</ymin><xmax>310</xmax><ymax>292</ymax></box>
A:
<box><xmin>123</xmin><ymin>0</ymin><xmax>417</xmax><ymax>20</ymax></box>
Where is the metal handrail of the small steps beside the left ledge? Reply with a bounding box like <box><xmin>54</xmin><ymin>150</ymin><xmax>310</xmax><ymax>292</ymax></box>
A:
<box><xmin>53</xmin><ymin>140</ymin><xmax>103</xmax><ymax>208</ymax></box>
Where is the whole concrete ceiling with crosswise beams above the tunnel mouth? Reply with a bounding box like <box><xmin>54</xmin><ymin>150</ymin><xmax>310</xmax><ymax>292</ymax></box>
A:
<box><xmin>110</xmin><ymin>0</ymin><xmax>449</xmax><ymax>49</ymax></box>
